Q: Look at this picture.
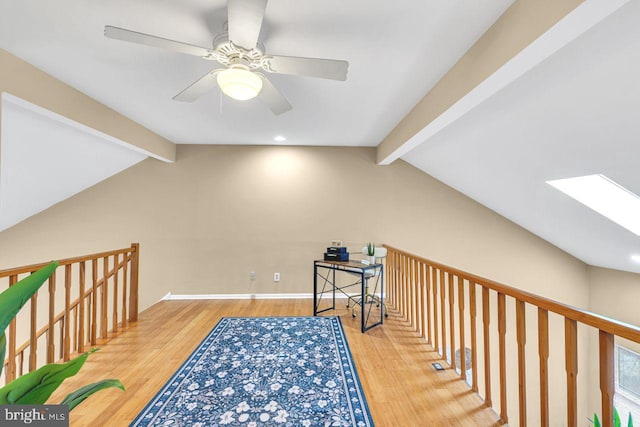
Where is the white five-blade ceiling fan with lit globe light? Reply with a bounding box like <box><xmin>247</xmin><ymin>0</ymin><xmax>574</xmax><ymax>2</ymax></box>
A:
<box><xmin>104</xmin><ymin>0</ymin><xmax>349</xmax><ymax>115</ymax></box>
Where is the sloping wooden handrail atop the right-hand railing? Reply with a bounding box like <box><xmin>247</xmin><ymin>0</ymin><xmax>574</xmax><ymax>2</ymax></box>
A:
<box><xmin>383</xmin><ymin>245</ymin><xmax>640</xmax><ymax>342</ymax></box>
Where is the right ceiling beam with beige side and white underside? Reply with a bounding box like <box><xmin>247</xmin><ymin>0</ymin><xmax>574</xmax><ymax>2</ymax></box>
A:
<box><xmin>377</xmin><ymin>0</ymin><xmax>629</xmax><ymax>165</ymax></box>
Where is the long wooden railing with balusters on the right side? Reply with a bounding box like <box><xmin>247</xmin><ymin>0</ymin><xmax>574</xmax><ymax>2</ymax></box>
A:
<box><xmin>384</xmin><ymin>245</ymin><xmax>640</xmax><ymax>427</ymax></box>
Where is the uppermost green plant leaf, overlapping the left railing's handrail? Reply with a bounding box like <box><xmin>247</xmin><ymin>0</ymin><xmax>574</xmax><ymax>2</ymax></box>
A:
<box><xmin>0</xmin><ymin>261</ymin><xmax>58</xmax><ymax>338</ymax></box>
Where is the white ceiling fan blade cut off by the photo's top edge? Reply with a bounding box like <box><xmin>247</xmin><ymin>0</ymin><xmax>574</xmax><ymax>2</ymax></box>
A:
<box><xmin>227</xmin><ymin>0</ymin><xmax>267</xmax><ymax>50</ymax></box>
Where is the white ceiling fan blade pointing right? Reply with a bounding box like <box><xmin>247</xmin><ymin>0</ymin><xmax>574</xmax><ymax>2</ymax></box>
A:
<box><xmin>267</xmin><ymin>56</ymin><xmax>349</xmax><ymax>81</ymax></box>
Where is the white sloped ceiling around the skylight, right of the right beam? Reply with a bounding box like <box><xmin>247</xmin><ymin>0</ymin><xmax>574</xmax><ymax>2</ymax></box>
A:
<box><xmin>402</xmin><ymin>1</ymin><xmax>640</xmax><ymax>273</ymax></box>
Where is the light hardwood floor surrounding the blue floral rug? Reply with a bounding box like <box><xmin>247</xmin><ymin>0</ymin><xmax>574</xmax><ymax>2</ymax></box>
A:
<box><xmin>51</xmin><ymin>300</ymin><xmax>499</xmax><ymax>427</ymax></box>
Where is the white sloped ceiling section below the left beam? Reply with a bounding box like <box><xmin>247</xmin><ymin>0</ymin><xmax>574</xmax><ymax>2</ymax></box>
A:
<box><xmin>0</xmin><ymin>93</ymin><xmax>147</xmax><ymax>231</ymax></box>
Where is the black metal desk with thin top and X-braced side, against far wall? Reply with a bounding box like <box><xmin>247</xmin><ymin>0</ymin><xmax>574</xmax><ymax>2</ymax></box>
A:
<box><xmin>313</xmin><ymin>260</ymin><xmax>384</xmax><ymax>332</ymax></box>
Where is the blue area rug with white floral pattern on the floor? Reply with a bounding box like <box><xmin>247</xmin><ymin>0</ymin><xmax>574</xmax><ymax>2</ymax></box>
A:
<box><xmin>131</xmin><ymin>317</ymin><xmax>373</xmax><ymax>427</ymax></box>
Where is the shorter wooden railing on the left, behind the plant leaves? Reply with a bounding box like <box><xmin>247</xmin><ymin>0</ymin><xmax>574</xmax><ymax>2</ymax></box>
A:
<box><xmin>0</xmin><ymin>243</ymin><xmax>140</xmax><ymax>384</ymax></box>
